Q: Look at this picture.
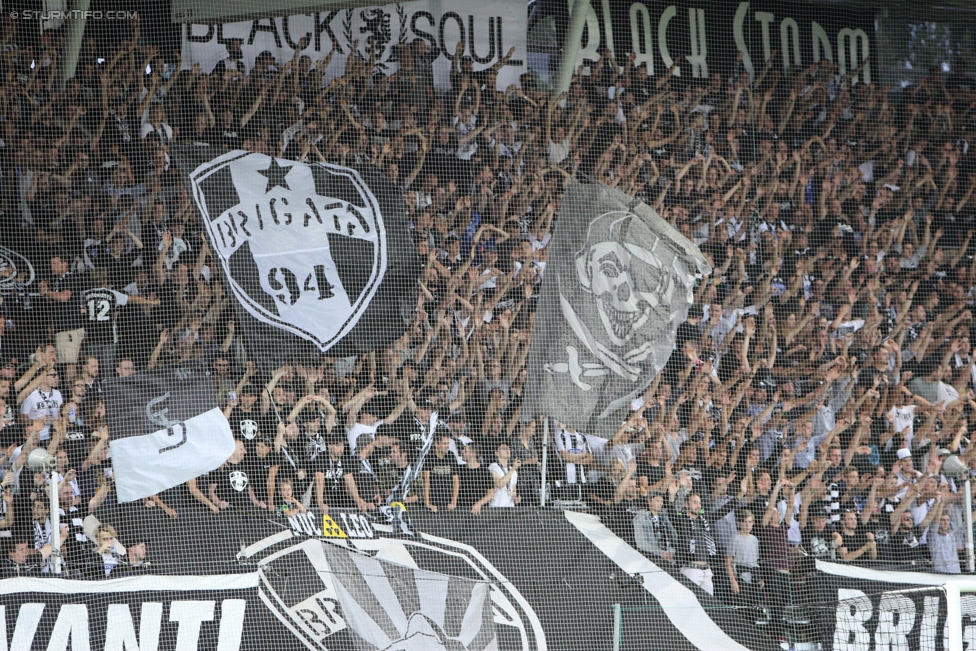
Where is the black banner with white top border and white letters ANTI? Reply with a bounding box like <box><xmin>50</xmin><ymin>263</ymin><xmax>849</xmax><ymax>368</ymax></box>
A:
<box><xmin>0</xmin><ymin>572</ymin><xmax>290</xmax><ymax>651</ymax></box>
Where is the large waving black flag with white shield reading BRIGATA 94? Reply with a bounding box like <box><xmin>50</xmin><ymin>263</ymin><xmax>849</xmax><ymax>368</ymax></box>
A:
<box><xmin>178</xmin><ymin>149</ymin><xmax>420</xmax><ymax>362</ymax></box>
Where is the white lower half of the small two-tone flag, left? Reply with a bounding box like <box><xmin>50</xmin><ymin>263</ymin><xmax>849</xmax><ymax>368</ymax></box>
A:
<box><xmin>109</xmin><ymin>407</ymin><xmax>234</xmax><ymax>502</ymax></box>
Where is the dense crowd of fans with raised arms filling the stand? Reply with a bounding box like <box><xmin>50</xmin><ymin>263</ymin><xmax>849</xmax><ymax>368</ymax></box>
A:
<box><xmin>0</xmin><ymin>14</ymin><xmax>976</xmax><ymax>628</ymax></box>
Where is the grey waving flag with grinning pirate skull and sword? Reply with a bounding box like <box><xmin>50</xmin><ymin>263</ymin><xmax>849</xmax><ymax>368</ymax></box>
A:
<box><xmin>522</xmin><ymin>183</ymin><xmax>711</xmax><ymax>437</ymax></box>
